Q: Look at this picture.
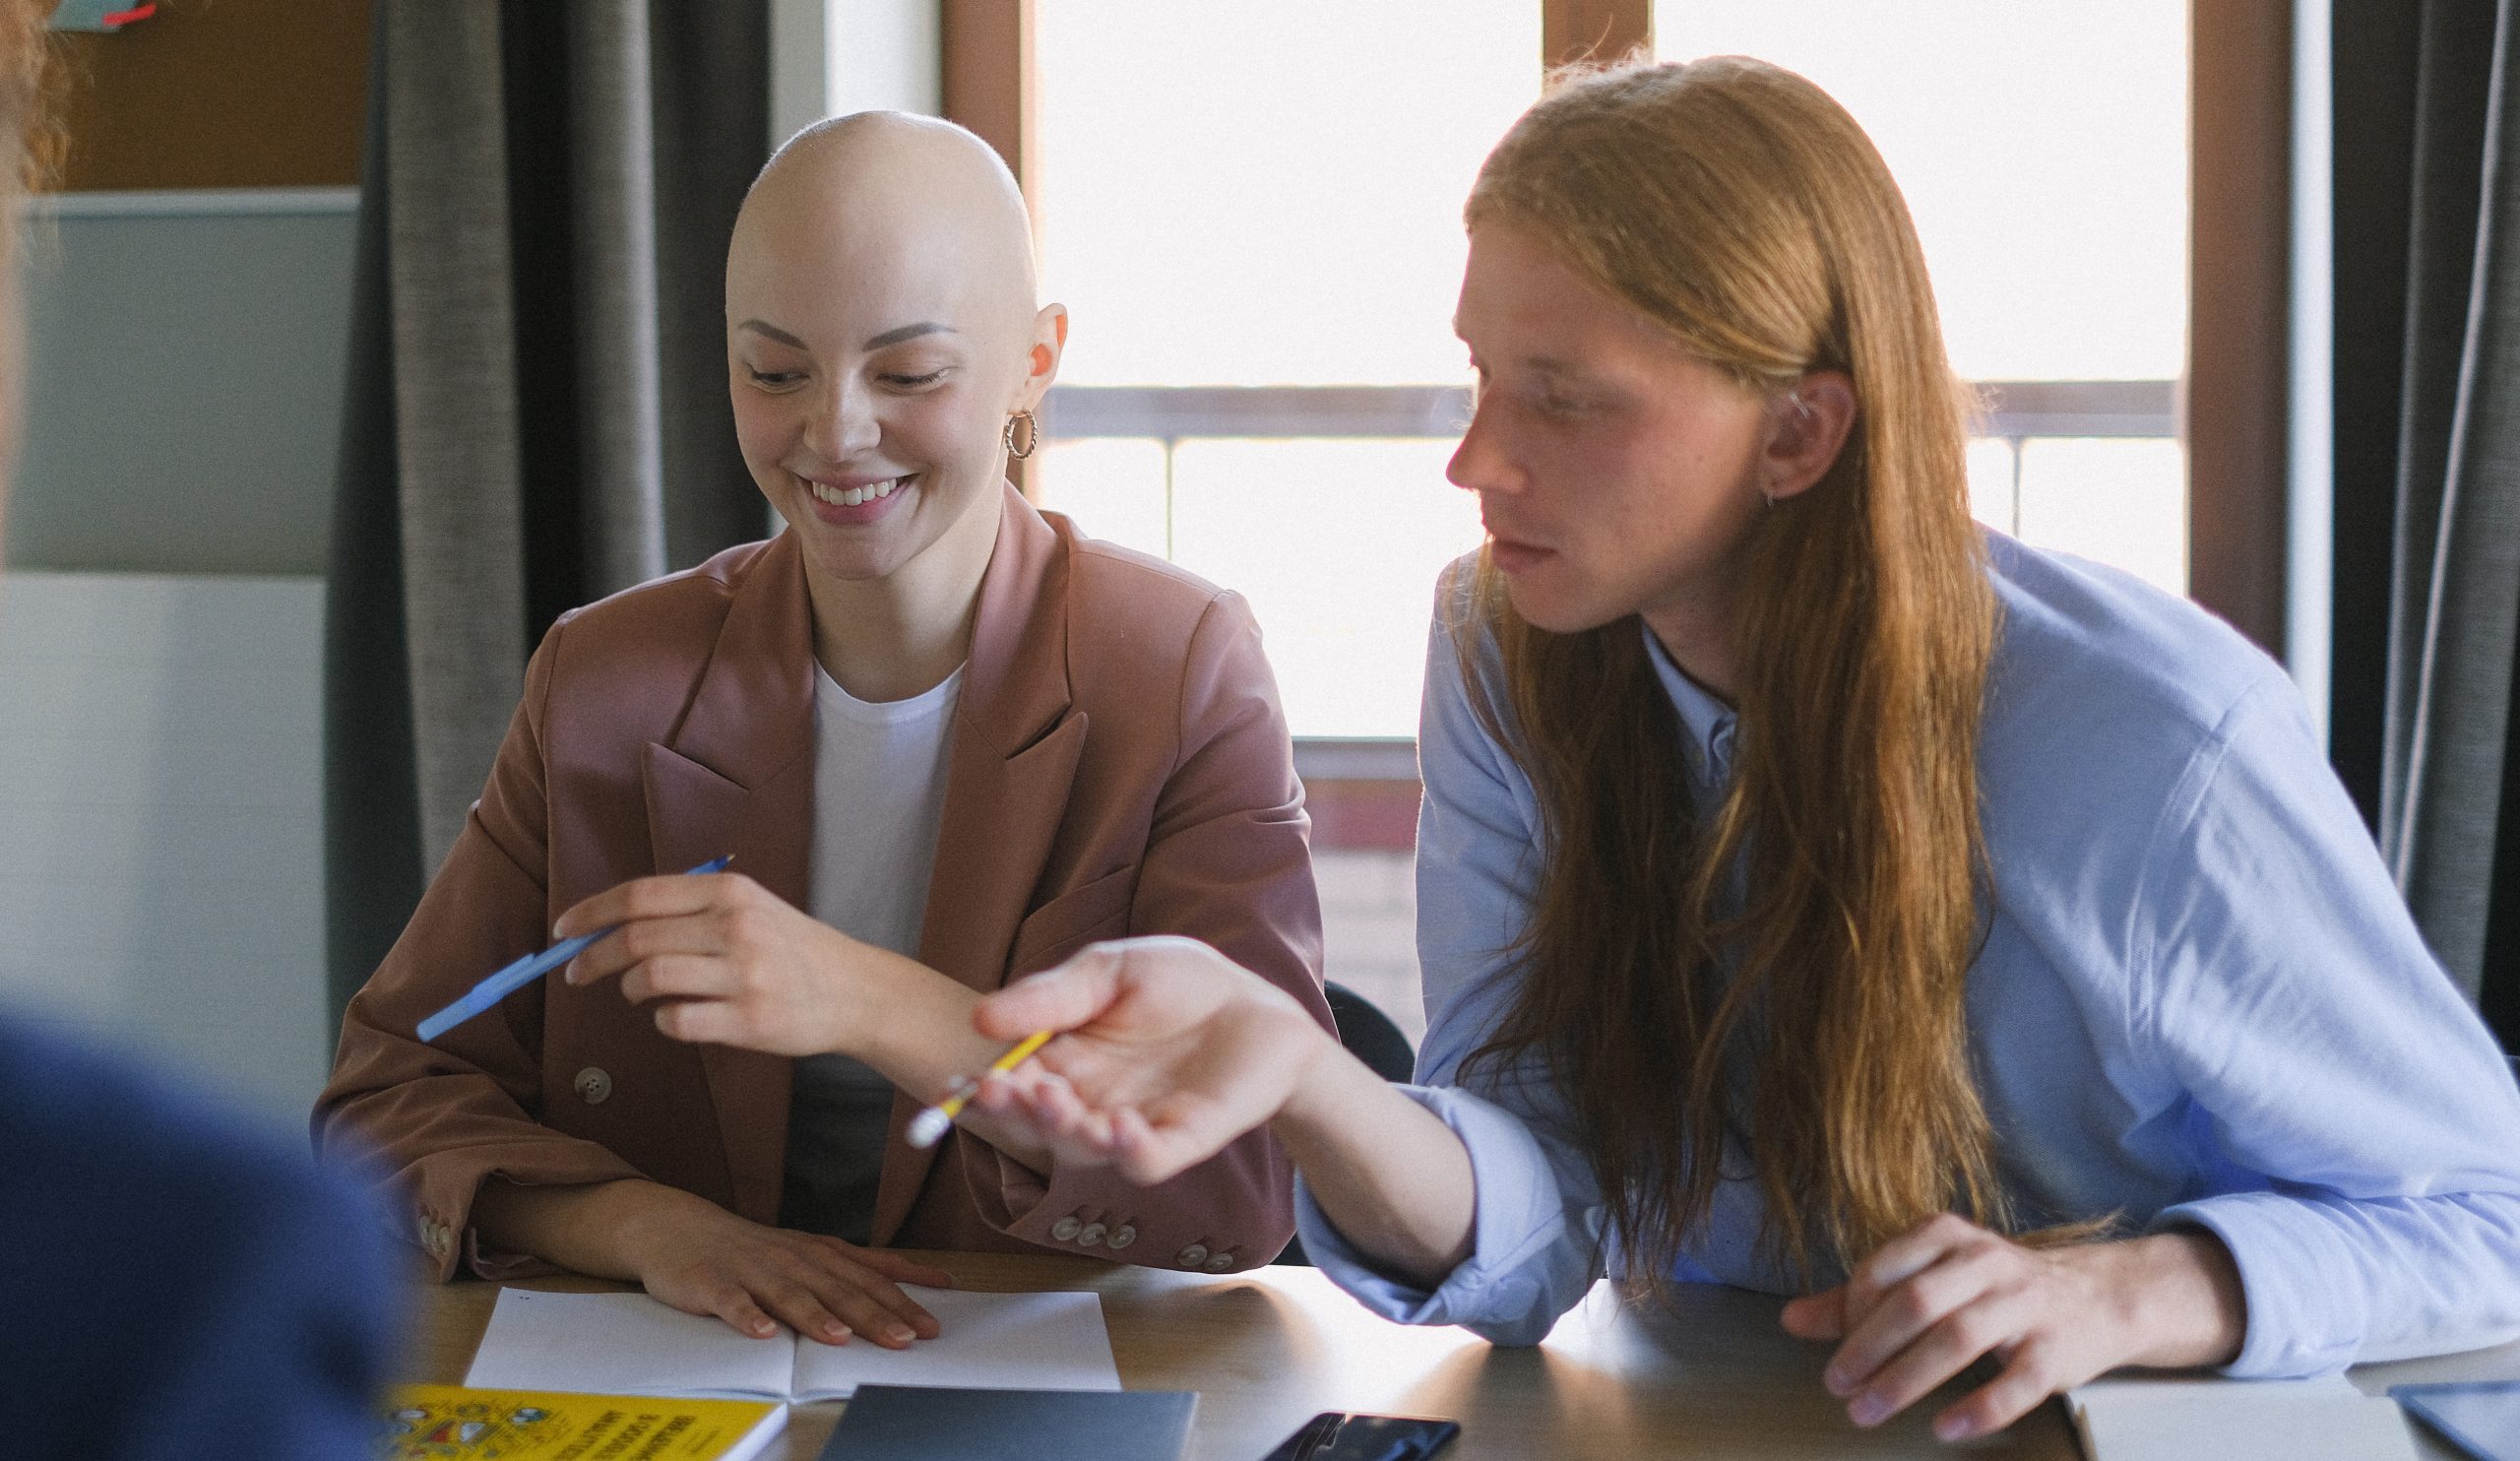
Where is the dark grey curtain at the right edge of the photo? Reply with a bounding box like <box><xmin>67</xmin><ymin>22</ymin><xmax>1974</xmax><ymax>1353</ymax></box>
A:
<box><xmin>2334</xmin><ymin>0</ymin><xmax>2520</xmax><ymax>1048</ymax></box>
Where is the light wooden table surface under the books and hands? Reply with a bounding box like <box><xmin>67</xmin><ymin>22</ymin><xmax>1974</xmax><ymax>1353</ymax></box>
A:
<box><xmin>406</xmin><ymin>1254</ymin><xmax>2520</xmax><ymax>1461</ymax></box>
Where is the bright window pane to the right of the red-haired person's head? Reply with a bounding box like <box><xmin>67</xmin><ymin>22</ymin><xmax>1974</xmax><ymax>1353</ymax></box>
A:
<box><xmin>1653</xmin><ymin>0</ymin><xmax>2187</xmax><ymax>592</ymax></box>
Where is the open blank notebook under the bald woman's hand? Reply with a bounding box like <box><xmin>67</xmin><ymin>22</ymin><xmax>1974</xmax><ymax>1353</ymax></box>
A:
<box><xmin>464</xmin><ymin>1285</ymin><xmax>1119</xmax><ymax>1401</ymax></box>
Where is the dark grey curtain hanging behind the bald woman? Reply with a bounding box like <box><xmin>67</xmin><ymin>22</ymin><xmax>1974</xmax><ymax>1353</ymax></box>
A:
<box><xmin>325</xmin><ymin>0</ymin><xmax>769</xmax><ymax>1015</ymax></box>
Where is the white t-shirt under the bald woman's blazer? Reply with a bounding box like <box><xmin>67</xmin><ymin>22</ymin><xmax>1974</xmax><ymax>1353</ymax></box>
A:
<box><xmin>779</xmin><ymin>665</ymin><xmax>963</xmax><ymax>1244</ymax></box>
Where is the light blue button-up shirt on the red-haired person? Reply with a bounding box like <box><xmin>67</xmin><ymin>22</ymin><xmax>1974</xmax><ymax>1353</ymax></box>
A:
<box><xmin>1297</xmin><ymin>537</ymin><xmax>2520</xmax><ymax>1375</ymax></box>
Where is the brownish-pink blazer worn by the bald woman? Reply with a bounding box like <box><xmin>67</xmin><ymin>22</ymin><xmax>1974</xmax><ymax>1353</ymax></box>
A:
<box><xmin>315</xmin><ymin>491</ymin><xmax>1331</xmax><ymax>1277</ymax></box>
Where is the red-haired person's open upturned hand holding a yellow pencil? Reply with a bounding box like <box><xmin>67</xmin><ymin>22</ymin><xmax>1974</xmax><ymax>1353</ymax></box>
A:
<box><xmin>973</xmin><ymin>937</ymin><xmax>1338</xmax><ymax>1186</ymax></box>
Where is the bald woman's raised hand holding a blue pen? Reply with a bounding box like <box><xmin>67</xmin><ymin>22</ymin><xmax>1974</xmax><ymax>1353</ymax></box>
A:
<box><xmin>552</xmin><ymin>871</ymin><xmax>892</xmax><ymax>1055</ymax></box>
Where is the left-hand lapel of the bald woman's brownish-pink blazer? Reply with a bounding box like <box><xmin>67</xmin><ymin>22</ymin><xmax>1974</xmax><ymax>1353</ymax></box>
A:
<box><xmin>640</xmin><ymin>534</ymin><xmax>814</xmax><ymax>1222</ymax></box>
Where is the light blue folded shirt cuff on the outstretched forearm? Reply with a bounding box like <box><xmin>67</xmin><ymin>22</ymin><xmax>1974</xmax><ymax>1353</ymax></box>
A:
<box><xmin>1295</xmin><ymin>1086</ymin><xmax>1593</xmax><ymax>1345</ymax></box>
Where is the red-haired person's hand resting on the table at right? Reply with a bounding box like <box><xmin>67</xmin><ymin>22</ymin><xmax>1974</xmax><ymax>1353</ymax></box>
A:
<box><xmin>1784</xmin><ymin>1214</ymin><xmax>2245</xmax><ymax>1441</ymax></box>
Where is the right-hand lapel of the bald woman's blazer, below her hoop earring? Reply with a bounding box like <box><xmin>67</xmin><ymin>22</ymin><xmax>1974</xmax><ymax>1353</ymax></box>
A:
<box><xmin>874</xmin><ymin>488</ymin><xmax>1086</xmax><ymax>1244</ymax></box>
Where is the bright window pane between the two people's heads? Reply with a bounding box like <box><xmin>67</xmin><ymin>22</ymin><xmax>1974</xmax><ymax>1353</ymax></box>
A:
<box><xmin>1036</xmin><ymin>0</ymin><xmax>1540</xmax><ymax>738</ymax></box>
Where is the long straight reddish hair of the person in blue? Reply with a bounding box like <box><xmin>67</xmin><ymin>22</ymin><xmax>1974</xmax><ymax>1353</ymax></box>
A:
<box><xmin>1462</xmin><ymin>58</ymin><xmax>2003</xmax><ymax>1282</ymax></box>
